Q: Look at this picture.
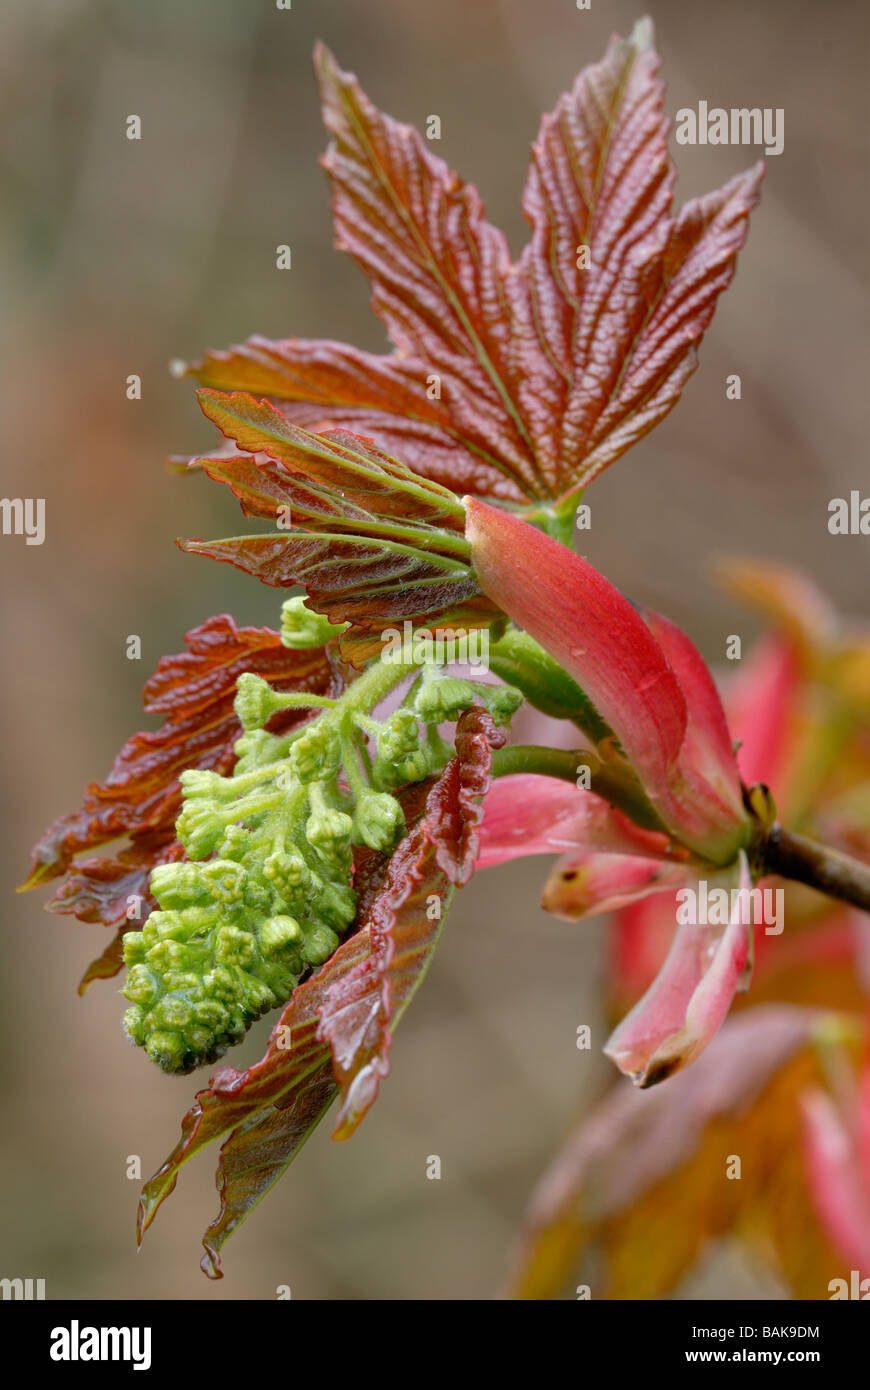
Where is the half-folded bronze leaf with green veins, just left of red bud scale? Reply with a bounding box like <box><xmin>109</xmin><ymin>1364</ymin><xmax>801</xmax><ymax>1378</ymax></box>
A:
<box><xmin>179</xmin><ymin>391</ymin><xmax>498</xmax><ymax>664</ymax></box>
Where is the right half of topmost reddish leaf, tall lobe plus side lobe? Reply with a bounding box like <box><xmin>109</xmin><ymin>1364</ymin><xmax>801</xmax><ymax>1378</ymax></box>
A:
<box><xmin>517</xmin><ymin>21</ymin><xmax>762</xmax><ymax>495</ymax></box>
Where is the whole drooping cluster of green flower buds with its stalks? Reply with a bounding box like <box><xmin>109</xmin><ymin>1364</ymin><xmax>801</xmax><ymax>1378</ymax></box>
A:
<box><xmin>122</xmin><ymin>599</ymin><xmax>521</xmax><ymax>1072</ymax></box>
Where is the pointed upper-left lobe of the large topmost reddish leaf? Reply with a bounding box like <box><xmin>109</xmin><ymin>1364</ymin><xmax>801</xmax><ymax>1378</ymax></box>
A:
<box><xmin>308</xmin><ymin>44</ymin><xmax>543</xmax><ymax>496</ymax></box>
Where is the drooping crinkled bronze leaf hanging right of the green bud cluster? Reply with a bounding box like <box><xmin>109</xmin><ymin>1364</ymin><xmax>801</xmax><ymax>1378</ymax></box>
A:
<box><xmin>139</xmin><ymin>710</ymin><xmax>503</xmax><ymax>1277</ymax></box>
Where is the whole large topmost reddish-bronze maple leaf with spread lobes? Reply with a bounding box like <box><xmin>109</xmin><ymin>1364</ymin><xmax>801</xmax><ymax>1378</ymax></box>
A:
<box><xmin>180</xmin><ymin>21</ymin><xmax>763</xmax><ymax>505</ymax></box>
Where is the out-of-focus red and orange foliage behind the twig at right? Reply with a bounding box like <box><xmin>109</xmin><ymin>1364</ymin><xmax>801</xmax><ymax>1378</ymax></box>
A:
<box><xmin>510</xmin><ymin>562</ymin><xmax>870</xmax><ymax>1298</ymax></box>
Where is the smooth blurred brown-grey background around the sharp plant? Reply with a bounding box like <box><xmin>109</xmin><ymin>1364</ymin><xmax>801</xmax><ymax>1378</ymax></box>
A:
<box><xmin>0</xmin><ymin>0</ymin><xmax>870</xmax><ymax>1300</ymax></box>
